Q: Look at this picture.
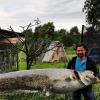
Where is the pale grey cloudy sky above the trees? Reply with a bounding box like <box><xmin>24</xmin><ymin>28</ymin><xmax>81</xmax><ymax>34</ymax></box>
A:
<box><xmin>0</xmin><ymin>0</ymin><xmax>86</xmax><ymax>31</ymax></box>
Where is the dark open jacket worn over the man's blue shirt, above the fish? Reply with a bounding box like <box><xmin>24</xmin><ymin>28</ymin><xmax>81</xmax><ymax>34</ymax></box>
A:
<box><xmin>67</xmin><ymin>57</ymin><xmax>97</xmax><ymax>75</ymax></box>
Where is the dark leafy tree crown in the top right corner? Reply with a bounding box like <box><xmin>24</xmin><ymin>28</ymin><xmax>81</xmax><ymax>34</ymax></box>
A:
<box><xmin>83</xmin><ymin>0</ymin><xmax>100</xmax><ymax>28</ymax></box>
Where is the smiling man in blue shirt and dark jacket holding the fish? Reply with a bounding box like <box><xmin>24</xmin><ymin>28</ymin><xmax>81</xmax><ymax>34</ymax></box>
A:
<box><xmin>67</xmin><ymin>43</ymin><xmax>97</xmax><ymax>100</ymax></box>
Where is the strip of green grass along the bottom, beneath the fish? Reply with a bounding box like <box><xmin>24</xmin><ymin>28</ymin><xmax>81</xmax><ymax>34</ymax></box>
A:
<box><xmin>2</xmin><ymin>92</ymin><xmax>71</xmax><ymax>100</ymax></box>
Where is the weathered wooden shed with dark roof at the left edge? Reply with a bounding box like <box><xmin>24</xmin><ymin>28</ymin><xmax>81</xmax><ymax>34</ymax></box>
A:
<box><xmin>0</xmin><ymin>29</ymin><xmax>19</xmax><ymax>73</ymax></box>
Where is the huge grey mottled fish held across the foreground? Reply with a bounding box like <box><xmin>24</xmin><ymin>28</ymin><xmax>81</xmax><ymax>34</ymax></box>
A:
<box><xmin>0</xmin><ymin>68</ymin><xmax>97</xmax><ymax>93</ymax></box>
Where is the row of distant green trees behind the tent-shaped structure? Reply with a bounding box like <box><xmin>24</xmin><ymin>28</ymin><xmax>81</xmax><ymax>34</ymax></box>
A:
<box><xmin>54</xmin><ymin>27</ymin><xmax>80</xmax><ymax>47</ymax></box>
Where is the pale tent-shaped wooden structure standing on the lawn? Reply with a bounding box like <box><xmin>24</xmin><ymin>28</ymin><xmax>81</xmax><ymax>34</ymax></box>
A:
<box><xmin>42</xmin><ymin>41</ymin><xmax>68</xmax><ymax>62</ymax></box>
